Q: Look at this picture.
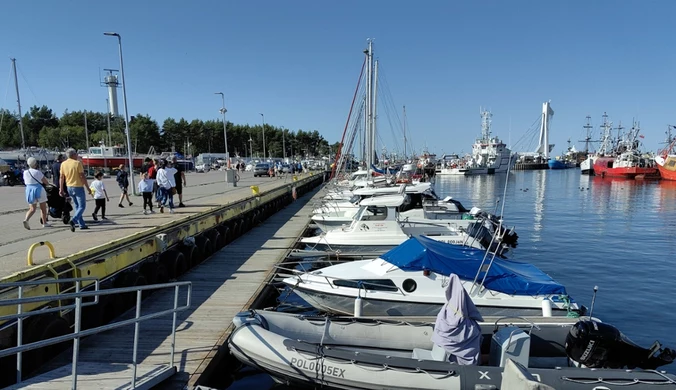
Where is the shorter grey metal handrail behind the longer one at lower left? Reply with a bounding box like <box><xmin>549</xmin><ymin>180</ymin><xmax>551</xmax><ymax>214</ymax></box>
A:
<box><xmin>0</xmin><ymin>277</ymin><xmax>99</xmax><ymax>383</ymax></box>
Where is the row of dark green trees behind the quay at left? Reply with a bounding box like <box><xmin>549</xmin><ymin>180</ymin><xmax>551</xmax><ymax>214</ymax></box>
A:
<box><xmin>0</xmin><ymin>106</ymin><xmax>337</xmax><ymax>158</ymax></box>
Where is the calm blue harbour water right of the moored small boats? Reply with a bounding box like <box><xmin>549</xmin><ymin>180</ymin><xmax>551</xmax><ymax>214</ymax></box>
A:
<box><xmin>231</xmin><ymin>169</ymin><xmax>676</xmax><ymax>389</ymax></box>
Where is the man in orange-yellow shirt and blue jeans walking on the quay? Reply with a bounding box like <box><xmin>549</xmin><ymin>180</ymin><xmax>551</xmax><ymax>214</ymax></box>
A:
<box><xmin>59</xmin><ymin>149</ymin><xmax>92</xmax><ymax>232</ymax></box>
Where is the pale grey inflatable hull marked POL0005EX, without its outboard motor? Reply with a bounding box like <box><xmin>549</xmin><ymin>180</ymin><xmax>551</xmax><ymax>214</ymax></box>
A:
<box><xmin>228</xmin><ymin>312</ymin><xmax>676</xmax><ymax>390</ymax></box>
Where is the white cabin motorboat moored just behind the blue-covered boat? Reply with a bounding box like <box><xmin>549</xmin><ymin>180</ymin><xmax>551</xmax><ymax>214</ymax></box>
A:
<box><xmin>301</xmin><ymin>194</ymin><xmax>518</xmax><ymax>256</ymax></box>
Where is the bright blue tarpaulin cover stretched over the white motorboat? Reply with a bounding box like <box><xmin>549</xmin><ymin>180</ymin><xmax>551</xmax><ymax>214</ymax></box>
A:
<box><xmin>380</xmin><ymin>236</ymin><xmax>566</xmax><ymax>295</ymax></box>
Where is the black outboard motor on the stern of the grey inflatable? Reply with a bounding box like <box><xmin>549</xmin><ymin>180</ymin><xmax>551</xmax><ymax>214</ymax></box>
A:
<box><xmin>566</xmin><ymin>320</ymin><xmax>676</xmax><ymax>370</ymax></box>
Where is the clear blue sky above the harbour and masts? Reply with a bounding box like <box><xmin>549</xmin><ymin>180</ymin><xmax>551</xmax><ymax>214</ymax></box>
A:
<box><xmin>0</xmin><ymin>0</ymin><xmax>676</xmax><ymax>153</ymax></box>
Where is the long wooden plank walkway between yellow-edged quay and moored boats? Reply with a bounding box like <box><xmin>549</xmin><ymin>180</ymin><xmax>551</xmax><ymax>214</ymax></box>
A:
<box><xmin>25</xmin><ymin>184</ymin><xmax>316</xmax><ymax>389</ymax></box>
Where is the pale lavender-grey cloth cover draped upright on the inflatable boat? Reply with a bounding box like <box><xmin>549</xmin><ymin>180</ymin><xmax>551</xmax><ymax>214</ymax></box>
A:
<box><xmin>432</xmin><ymin>274</ymin><xmax>483</xmax><ymax>365</ymax></box>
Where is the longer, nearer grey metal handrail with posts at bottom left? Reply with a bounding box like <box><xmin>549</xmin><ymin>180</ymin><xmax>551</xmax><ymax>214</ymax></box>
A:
<box><xmin>0</xmin><ymin>281</ymin><xmax>192</xmax><ymax>390</ymax></box>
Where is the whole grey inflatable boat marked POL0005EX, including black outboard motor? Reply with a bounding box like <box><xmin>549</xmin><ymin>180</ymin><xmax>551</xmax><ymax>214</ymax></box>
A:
<box><xmin>228</xmin><ymin>311</ymin><xmax>676</xmax><ymax>390</ymax></box>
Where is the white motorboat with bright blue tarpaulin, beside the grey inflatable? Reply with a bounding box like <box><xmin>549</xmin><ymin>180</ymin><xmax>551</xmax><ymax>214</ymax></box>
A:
<box><xmin>283</xmin><ymin>237</ymin><xmax>572</xmax><ymax>316</ymax></box>
